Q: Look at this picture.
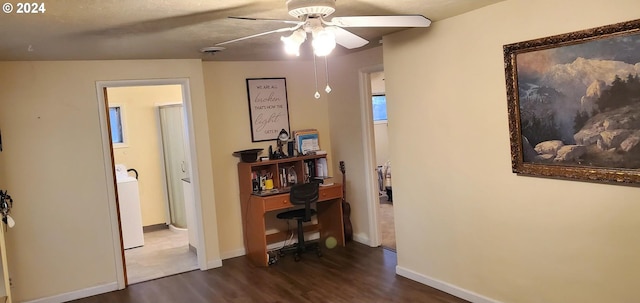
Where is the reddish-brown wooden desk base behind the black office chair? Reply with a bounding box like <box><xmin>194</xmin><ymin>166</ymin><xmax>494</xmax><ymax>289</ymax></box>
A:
<box><xmin>242</xmin><ymin>184</ymin><xmax>345</xmax><ymax>266</ymax></box>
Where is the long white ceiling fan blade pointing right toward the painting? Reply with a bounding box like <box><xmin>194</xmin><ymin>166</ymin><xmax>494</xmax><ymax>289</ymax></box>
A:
<box><xmin>328</xmin><ymin>15</ymin><xmax>431</xmax><ymax>27</ymax></box>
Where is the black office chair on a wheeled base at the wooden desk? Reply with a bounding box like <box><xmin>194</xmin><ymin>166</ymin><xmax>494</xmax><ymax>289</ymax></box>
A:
<box><xmin>276</xmin><ymin>182</ymin><xmax>322</xmax><ymax>261</ymax></box>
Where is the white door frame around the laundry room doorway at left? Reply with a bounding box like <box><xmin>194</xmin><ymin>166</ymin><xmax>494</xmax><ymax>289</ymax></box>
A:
<box><xmin>96</xmin><ymin>78</ymin><xmax>207</xmax><ymax>289</ymax></box>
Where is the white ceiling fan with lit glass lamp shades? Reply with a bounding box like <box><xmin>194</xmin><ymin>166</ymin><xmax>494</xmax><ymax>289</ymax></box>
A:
<box><xmin>216</xmin><ymin>0</ymin><xmax>431</xmax><ymax>56</ymax></box>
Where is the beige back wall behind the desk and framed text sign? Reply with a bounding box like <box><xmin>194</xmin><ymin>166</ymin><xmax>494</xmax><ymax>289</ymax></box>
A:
<box><xmin>203</xmin><ymin>60</ymin><xmax>340</xmax><ymax>258</ymax></box>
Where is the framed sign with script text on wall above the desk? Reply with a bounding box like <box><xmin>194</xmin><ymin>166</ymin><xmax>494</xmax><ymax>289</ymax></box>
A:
<box><xmin>247</xmin><ymin>78</ymin><xmax>291</xmax><ymax>142</ymax></box>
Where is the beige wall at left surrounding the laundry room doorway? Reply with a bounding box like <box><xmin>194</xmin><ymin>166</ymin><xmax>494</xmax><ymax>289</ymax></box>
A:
<box><xmin>0</xmin><ymin>60</ymin><xmax>220</xmax><ymax>301</ymax></box>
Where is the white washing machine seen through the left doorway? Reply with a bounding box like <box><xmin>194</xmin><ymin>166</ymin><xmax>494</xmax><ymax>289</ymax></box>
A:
<box><xmin>116</xmin><ymin>164</ymin><xmax>144</xmax><ymax>249</ymax></box>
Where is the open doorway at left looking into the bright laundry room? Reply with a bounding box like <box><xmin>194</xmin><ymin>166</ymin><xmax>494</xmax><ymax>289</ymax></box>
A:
<box><xmin>106</xmin><ymin>85</ymin><xmax>198</xmax><ymax>284</ymax></box>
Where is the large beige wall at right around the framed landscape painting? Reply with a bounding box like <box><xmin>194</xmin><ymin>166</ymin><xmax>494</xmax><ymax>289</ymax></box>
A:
<box><xmin>384</xmin><ymin>0</ymin><xmax>640</xmax><ymax>303</ymax></box>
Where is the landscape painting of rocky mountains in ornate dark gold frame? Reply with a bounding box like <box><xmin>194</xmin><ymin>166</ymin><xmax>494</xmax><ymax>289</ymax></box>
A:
<box><xmin>503</xmin><ymin>20</ymin><xmax>640</xmax><ymax>184</ymax></box>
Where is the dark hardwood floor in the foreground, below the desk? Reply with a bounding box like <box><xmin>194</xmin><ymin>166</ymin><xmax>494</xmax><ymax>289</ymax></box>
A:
<box><xmin>73</xmin><ymin>242</ymin><xmax>467</xmax><ymax>303</ymax></box>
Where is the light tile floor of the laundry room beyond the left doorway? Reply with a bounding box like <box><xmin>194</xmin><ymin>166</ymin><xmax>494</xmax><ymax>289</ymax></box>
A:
<box><xmin>124</xmin><ymin>229</ymin><xmax>198</xmax><ymax>284</ymax></box>
